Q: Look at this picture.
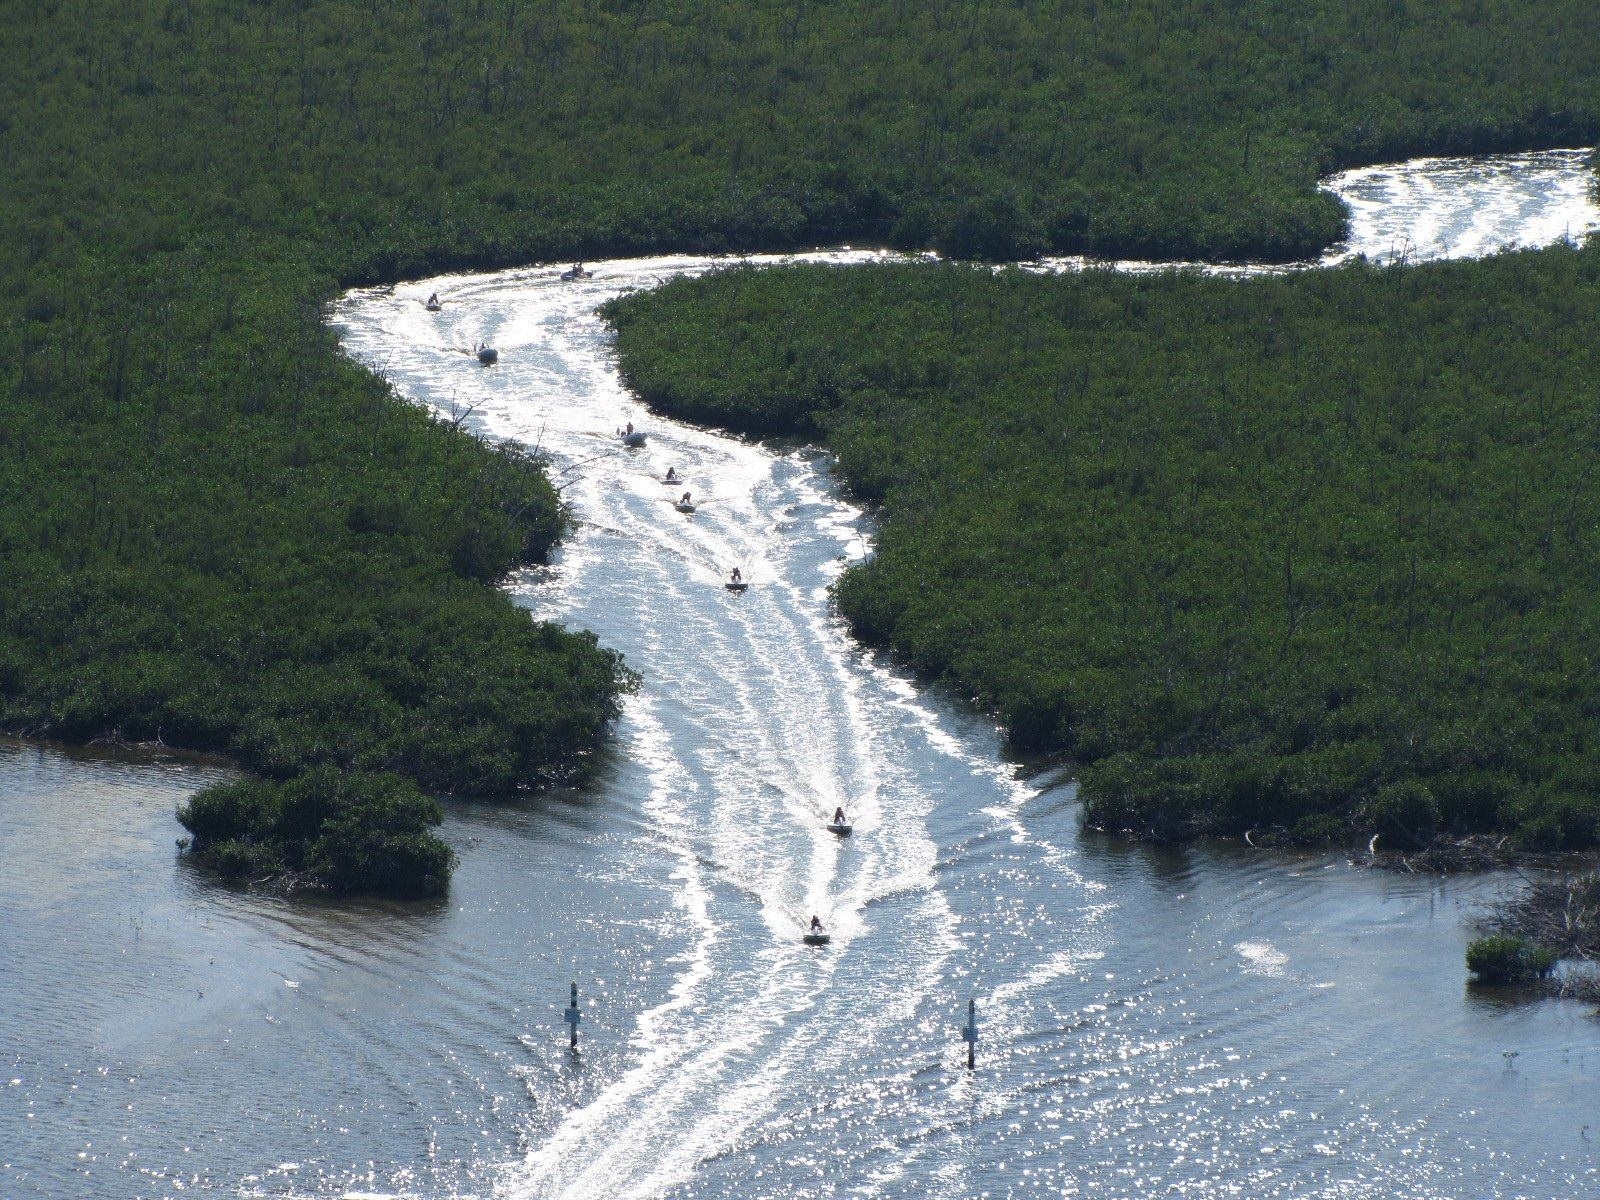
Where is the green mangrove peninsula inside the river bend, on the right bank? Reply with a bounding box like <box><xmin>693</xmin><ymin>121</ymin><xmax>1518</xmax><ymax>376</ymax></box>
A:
<box><xmin>608</xmin><ymin>248</ymin><xmax>1600</xmax><ymax>850</ymax></box>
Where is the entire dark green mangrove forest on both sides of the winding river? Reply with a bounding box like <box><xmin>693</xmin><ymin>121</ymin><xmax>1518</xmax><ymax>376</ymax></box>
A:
<box><xmin>9</xmin><ymin>0</ymin><xmax>1600</xmax><ymax>891</ymax></box>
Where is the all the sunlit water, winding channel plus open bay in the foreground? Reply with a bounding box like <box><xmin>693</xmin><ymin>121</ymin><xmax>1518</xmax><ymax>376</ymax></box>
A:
<box><xmin>0</xmin><ymin>152</ymin><xmax>1600</xmax><ymax>1200</ymax></box>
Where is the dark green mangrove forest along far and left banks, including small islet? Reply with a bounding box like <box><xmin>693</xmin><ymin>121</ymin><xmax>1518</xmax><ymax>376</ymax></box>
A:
<box><xmin>9</xmin><ymin>0</ymin><xmax>1600</xmax><ymax>890</ymax></box>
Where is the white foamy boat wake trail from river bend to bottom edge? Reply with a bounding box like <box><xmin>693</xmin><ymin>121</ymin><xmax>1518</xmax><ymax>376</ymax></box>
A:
<box><xmin>342</xmin><ymin>253</ymin><xmax>957</xmax><ymax>1197</ymax></box>
